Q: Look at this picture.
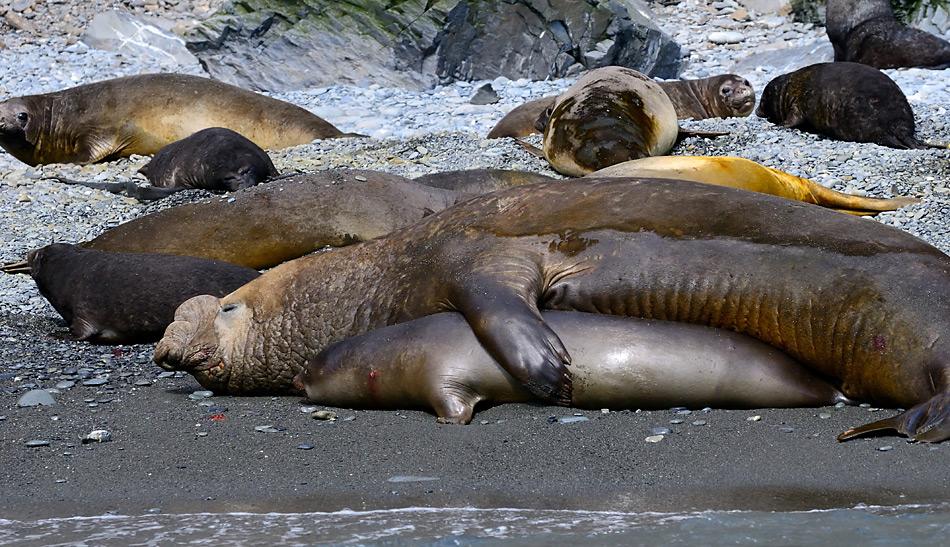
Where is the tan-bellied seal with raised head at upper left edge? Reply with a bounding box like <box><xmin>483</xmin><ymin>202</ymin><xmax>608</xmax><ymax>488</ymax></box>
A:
<box><xmin>0</xmin><ymin>74</ymin><xmax>346</xmax><ymax>165</ymax></box>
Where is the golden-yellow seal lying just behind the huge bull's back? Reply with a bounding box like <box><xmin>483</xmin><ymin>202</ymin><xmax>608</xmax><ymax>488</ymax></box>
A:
<box><xmin>587</xmin><ymin>156</ymin><xmax>919</xmax><ymax>215</ymax></box>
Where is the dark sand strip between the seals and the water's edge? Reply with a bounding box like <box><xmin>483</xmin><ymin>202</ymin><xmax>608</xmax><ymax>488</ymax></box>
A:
<box><xmin>0</xmin><ymin>315</ymin><xmax>950</xmax><ymax>519</ymax></box>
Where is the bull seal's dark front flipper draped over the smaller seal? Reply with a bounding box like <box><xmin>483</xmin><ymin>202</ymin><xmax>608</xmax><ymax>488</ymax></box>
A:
<box><xmin>457</xmin><ymin>284</ymin><xmax>571</xmax><ymax>405</ymax></box>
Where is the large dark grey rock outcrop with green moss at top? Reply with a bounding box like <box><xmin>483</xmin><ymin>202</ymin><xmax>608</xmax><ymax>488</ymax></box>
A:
<box><xmin>187</xmin><ymin>0</ymin><xmax>681</xmax><ymax>91</ymax></box>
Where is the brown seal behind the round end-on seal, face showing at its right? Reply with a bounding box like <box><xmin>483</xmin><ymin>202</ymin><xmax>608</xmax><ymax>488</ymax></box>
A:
<box><xmin>488</xmin><ymin>74</ymin><xmax>755</xmax><ymax>139</ymax></box>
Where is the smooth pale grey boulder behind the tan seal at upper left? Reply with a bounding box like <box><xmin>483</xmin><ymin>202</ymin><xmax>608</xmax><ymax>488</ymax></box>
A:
<box><xmin>82</xmin><ymin>10</ymin><xmax>198</xmax><ymax>66</ymax></box>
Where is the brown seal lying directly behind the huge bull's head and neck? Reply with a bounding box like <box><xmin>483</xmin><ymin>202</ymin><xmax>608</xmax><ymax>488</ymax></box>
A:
<box><xmin>83</xmin><ymin>170</ymin><xmax>463</xmax><ymax>270</ymax></box>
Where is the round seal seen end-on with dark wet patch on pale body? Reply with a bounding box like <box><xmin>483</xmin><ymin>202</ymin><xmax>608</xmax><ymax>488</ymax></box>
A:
<box><xmin>543</xmin><ymin>66</ymin><xmax>679</xmax><ymax>177</ymax></box>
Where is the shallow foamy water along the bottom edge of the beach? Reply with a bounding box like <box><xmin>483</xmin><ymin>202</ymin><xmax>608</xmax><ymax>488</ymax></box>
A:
<box><xmin>0</xmin><ymin>503</ymin><xmax>950</xmax><ymax>546</ymax></box>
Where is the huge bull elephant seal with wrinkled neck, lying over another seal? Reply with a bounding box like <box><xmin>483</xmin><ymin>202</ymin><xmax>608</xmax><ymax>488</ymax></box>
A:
<box><xmin>154</xmin><ymin>178</ymin><xmax>950</xmax><ymax>440</ymax></box>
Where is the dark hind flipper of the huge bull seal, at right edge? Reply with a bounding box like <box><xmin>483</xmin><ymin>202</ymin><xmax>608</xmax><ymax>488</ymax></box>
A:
<box><xmin>838</xmin><ymin>391</ymin><xmax>950</xmax><ymax>443</ymax></box>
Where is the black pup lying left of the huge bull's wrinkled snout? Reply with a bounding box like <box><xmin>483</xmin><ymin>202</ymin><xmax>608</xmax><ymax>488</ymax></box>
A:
<box><xmin>27</xmin><ymin>243</ymin><xmax>260</xmax><ymax>344</ymax></box>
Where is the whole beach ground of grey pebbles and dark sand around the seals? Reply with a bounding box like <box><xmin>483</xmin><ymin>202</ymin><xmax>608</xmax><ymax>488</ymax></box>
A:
<box><xmin>0</xmin><ymin>0</ymin><xmax>950</xmax><ymax>518</ymax></box>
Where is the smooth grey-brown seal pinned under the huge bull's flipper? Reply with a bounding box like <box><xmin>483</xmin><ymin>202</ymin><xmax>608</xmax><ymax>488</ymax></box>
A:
<box><xmin>296</xmin><ymin>311</ymin><xmax>846</xmax><ymax>424</ymax></box>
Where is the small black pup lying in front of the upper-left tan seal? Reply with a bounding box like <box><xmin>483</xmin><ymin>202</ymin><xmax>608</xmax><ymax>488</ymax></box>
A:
<box><xmin>56</xmin><ymin>127</ymin><xmax>277</xmax><ymax>201</ymax></box>
